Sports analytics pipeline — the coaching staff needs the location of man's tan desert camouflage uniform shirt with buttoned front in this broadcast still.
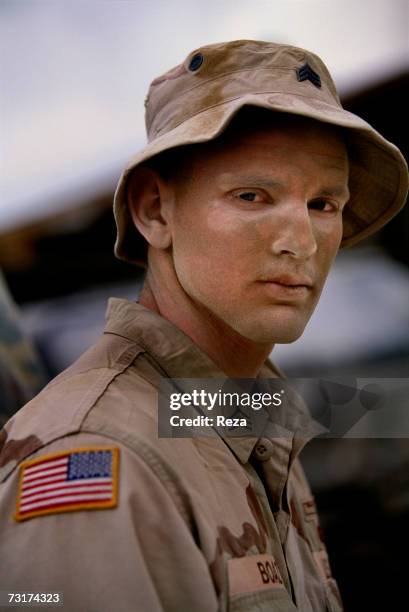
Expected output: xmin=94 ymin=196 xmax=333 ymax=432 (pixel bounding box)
xmin=0 ymin=299 xmax=342 ymax=612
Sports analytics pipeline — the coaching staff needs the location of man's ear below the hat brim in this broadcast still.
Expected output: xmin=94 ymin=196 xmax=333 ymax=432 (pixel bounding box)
xmin=127 ymin=166 xmax=173 ymax=249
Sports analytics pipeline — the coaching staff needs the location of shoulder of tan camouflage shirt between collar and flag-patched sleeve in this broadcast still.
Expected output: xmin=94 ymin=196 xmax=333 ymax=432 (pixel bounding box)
xmin=0 ymin=334 xmax=159 ymax=479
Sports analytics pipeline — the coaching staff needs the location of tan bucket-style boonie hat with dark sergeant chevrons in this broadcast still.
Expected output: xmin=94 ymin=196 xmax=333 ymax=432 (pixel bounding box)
xmin=114 ymin=40 xmax=408 ymax=263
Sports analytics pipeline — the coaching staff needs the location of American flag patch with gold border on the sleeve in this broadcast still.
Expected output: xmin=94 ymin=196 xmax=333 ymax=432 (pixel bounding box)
xmin=14 ymin=447 xmax=119 ymax=521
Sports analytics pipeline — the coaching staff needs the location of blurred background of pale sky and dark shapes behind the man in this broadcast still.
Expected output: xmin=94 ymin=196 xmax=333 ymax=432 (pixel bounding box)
xmin=0 ymin=0 xmax=409 ymax=611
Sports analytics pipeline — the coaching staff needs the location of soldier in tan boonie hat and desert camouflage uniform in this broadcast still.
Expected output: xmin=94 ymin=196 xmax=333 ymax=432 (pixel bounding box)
xmin=0 ymin=41 xmax=408 ymax=612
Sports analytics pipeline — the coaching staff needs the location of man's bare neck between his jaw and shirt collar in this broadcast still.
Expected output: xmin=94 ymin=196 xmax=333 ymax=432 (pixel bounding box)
xmin=139 ymin=275 xmax=274 ymax=378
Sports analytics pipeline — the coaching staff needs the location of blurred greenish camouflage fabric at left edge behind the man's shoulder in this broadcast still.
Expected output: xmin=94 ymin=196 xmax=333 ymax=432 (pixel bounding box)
xmin=0 ymin=272 xmax=46 ymax=425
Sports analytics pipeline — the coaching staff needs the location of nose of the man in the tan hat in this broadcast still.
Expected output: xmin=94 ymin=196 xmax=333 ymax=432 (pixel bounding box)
xmin=272 ymin=204 xmax=317 ymax=259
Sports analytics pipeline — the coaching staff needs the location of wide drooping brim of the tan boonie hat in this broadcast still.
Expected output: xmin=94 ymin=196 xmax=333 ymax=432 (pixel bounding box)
xmin=114 ymin=92 xmax=408 ymax=265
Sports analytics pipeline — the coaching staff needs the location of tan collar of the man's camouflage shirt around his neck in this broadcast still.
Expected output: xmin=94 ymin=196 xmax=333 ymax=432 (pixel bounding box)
xmin=105 ymin=298 xmax=312 ymax=464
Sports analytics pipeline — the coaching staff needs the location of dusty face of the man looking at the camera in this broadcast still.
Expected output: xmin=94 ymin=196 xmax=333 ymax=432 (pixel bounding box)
xmin=165 ymin=120 xmax=349 ymax=343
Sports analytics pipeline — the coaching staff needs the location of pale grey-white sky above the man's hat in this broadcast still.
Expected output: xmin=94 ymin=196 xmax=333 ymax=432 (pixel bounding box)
xmin=0 ymin=0 xmax=409 ymax=232
